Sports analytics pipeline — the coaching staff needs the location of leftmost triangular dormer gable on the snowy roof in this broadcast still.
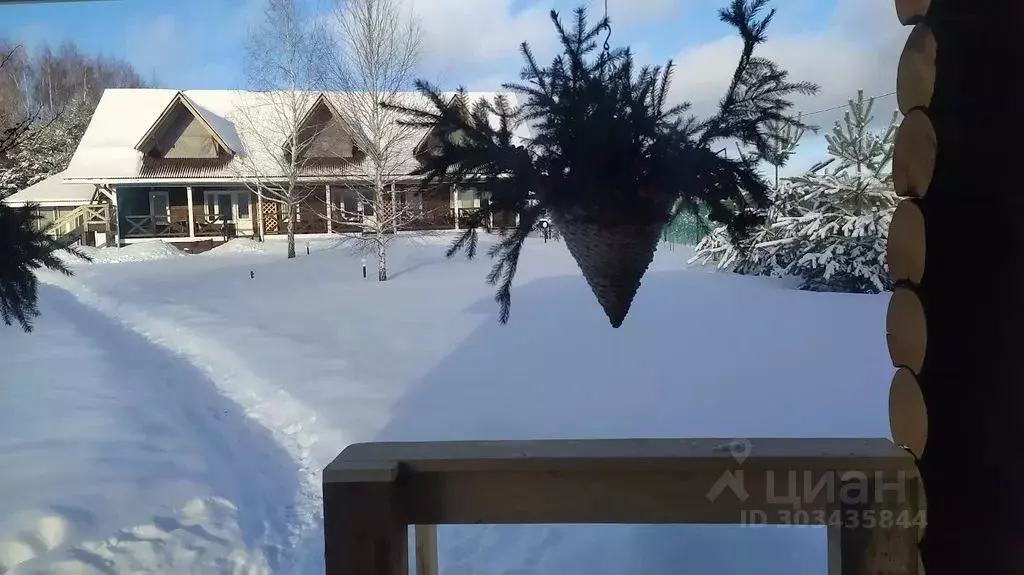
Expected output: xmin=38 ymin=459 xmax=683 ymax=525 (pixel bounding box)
xmin=135 ymin=92 xmax=234 ymax=160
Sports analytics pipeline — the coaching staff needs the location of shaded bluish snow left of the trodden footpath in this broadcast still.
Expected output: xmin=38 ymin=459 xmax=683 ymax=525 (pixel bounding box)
xmin=0 ymin=284 xmax=299 ymax=574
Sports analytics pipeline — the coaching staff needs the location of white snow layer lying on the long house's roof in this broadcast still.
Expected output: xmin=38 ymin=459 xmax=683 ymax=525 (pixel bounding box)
xmin=65 ymin=88 xmax=527 ymax=182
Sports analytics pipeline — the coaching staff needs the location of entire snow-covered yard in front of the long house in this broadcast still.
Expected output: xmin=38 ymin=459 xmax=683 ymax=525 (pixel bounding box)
xmin=0 ymin=233 xmax=892 ymax=575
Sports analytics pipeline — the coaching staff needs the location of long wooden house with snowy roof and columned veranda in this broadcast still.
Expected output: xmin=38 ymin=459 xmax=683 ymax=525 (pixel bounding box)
xmin=6 ymin=89 xmax=514 ymax=245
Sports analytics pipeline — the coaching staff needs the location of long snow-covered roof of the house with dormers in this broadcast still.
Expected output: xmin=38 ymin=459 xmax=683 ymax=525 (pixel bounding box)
xmin=65 ymin=88 xmax=528 ymax=183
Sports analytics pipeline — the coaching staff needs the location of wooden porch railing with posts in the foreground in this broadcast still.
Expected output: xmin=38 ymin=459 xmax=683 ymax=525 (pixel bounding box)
xmin=324 ymin=439 xmax=924 ymax=575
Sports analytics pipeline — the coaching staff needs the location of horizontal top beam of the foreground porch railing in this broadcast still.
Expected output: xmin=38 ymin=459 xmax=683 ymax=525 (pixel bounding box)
xmin=324 ymin=439 xmax=915 ymax=525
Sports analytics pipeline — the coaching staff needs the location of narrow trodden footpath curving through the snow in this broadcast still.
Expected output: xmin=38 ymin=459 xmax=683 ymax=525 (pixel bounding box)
xmin=39 ymin=272 xmax=323 ymax=572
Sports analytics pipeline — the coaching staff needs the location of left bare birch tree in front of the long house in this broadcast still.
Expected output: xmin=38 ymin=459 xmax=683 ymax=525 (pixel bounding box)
xmin=233 ymin=0 xmax=327 ymax=258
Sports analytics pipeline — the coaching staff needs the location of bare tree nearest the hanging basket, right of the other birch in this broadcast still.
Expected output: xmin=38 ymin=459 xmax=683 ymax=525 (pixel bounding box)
xmin=330 ymin=0 xmax=431 ymax=281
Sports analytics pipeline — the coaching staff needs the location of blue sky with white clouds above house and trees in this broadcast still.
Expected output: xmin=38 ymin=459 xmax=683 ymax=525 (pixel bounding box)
xmin=0 ymin=0 xmax=907 ymax=168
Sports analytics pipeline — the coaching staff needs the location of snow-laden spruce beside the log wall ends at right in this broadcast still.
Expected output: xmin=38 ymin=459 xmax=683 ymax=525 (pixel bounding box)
xmin=694 ymin=92 xmax=898 ymax=293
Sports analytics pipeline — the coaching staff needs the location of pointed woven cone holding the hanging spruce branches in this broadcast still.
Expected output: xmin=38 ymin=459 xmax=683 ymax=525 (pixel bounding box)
xmin=553 ymin=214 xmax=664 ymax=327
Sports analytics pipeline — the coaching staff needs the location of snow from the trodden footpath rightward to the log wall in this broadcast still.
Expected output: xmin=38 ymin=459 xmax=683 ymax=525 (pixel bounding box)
xmin=37 ymin=235 xmax=892 ymax=575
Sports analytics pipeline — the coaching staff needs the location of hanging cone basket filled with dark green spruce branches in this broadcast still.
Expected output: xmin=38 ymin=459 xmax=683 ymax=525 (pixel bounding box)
xmin=395 ymin=0 xmax=817 ymax=327
